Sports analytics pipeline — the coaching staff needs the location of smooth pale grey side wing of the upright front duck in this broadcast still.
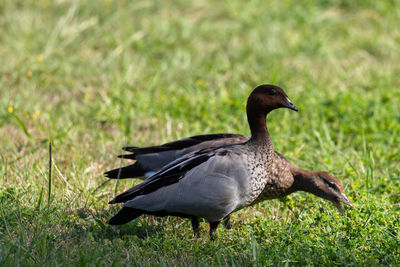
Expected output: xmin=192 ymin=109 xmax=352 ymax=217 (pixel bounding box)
xmin=125 ymin=153 xmax=249 ymax=224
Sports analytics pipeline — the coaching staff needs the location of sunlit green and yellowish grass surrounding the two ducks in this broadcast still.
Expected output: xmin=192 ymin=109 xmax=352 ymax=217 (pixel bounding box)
xmin=0 ymin=0 xmax=400 ymax=266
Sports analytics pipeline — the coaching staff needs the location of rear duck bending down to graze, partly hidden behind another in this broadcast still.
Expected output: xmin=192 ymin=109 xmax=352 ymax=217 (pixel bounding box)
xmin=105 ymin=137 xmax=353 ymax=232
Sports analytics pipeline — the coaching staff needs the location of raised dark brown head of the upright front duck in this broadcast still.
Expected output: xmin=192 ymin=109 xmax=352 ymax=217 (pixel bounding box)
xmin=247 ymin=84 xmax=298 ymax=115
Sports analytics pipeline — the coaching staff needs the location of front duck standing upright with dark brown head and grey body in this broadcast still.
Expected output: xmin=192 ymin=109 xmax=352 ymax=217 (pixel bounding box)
xmin=108 ymin=84 xmax=298 ymax=239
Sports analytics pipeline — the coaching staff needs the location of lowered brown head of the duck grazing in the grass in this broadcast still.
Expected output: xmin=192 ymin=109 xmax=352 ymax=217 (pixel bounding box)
xmin=311 ymin=172 xmax=353 ymax=214
